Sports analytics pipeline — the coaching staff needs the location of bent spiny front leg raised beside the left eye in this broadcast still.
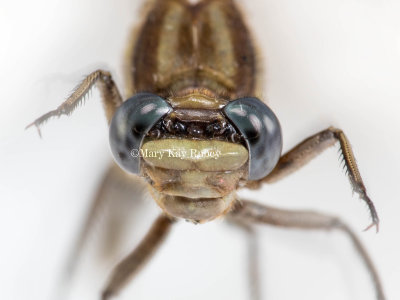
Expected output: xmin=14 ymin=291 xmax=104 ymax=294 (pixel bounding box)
xmin=26 ymin=70 xmax=122 ymax=135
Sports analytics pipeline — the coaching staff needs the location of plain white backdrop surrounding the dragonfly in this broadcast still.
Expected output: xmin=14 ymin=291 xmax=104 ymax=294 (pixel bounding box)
xmin=0 ymin=0 xmax=400 ymax=300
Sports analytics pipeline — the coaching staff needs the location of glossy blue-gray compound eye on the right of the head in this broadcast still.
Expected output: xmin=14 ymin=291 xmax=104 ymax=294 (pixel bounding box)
xmin=223 ymin=98 xmax=282 ymax=180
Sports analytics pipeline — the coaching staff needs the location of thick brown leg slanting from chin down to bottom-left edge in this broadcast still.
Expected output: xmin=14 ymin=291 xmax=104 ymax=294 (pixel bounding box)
xmin=101 ymin=215 xmax=174 ymax=300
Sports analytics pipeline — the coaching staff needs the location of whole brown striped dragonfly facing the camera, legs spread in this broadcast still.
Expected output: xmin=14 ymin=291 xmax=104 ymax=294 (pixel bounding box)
xmin=28 ymin=0 xmax=385 ymax=300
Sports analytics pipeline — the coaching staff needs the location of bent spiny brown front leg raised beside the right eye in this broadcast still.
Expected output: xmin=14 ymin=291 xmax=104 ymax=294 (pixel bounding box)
xmin=247 ymin=127 xmax=379 ymax=232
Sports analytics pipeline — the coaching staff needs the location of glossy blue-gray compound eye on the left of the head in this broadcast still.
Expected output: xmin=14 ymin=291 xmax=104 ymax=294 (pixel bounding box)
xmin=109 ymin=93 xmax=172 ymax=174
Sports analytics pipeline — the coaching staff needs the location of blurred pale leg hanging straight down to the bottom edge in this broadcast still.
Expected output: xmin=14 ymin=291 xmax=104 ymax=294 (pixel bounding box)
xmin=227 ymin=215 xmax=262 ymax=300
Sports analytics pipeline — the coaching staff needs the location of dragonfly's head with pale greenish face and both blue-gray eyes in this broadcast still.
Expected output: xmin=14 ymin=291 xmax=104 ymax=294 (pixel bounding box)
xmin=110 ymin=92 xmax=282 ymax=222
